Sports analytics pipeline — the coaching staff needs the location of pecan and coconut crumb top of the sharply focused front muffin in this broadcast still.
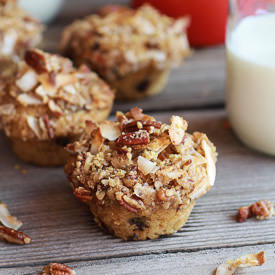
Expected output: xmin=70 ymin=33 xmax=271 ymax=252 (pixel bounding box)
xmin=65 ymin=107 xmax=216 ymax=216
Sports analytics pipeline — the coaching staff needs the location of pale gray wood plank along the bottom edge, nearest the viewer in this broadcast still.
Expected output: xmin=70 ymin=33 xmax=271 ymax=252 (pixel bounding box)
xmin=0 ymin=244 xmax=275 ymax=275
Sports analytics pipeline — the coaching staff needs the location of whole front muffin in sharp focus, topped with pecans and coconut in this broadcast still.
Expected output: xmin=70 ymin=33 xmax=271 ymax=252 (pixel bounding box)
xmin=65 ymin=107 xmax=216 ymax=240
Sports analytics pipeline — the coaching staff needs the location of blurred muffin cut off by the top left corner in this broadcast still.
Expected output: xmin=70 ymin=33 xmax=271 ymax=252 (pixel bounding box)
xmin=0 ymin=0 xmax=43 ymax=77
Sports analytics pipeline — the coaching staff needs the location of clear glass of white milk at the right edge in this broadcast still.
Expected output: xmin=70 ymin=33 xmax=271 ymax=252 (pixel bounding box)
xmin=226 ymin=0 xmax=275 ymax=156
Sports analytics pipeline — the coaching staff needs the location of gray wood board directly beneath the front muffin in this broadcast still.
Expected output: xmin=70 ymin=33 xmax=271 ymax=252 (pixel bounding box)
xmin=0 ymin=110 xmax=275 ymax=268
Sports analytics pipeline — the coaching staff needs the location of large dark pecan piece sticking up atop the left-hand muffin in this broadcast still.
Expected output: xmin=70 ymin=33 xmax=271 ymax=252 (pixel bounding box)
xmin=25 ymin=50 xmax=47 ymax=74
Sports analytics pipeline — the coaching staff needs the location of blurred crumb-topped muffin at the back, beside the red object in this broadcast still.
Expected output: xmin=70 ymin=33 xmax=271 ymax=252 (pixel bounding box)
xmin=61 ymin=5 xmax=190 ymax=100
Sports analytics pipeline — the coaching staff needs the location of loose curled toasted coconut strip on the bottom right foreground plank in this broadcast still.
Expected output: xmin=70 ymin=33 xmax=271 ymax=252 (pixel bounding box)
xmin=215 ymin=251 xmax=265 ymax=275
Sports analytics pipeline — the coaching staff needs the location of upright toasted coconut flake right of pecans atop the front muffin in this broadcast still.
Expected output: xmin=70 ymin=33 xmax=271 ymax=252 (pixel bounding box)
xmin=169 ymin=116 xmax=188 ymax=145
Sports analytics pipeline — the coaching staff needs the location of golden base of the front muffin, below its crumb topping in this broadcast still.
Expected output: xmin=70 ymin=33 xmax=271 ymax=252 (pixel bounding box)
xmin=89 ymin=199 xmax=195 ymax=240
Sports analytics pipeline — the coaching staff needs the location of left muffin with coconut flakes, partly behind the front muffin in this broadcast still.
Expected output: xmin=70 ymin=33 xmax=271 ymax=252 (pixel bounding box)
xmin=0 ymin=50 xmax=114 ymax=166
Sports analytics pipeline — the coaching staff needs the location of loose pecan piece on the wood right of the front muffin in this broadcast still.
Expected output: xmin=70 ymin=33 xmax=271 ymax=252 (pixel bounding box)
xmin=237 ymin=200 xmax=274 ymax=222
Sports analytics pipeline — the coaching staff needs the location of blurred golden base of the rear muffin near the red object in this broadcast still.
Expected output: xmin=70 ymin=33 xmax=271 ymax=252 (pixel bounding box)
xmin=109 ymin=66 xmax=170 ymax=100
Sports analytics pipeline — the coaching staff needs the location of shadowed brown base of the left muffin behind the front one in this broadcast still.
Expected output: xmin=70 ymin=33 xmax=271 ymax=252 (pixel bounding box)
xmin=10 ymin=138 xmax=72 ymax=166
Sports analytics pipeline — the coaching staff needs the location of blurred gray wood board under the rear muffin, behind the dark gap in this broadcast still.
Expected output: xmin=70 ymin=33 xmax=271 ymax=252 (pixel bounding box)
xmin=44 ymin=0 xmax=225 ymax=111
